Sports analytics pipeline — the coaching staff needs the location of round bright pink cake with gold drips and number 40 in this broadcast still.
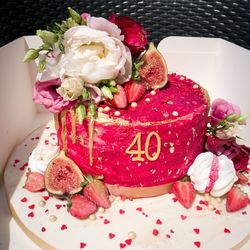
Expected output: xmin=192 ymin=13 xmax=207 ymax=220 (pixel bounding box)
xmin=56 ymin=74 xmax=209 ymax=197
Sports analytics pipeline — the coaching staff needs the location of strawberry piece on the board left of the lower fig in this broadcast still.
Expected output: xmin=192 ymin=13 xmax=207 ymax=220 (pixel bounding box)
xmin=24 ymin=172 xmax=45 ymax=192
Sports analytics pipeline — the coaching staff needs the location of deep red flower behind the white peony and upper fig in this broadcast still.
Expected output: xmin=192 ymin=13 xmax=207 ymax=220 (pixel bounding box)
xmin=109 ymin=13 xmax=148 ymax=55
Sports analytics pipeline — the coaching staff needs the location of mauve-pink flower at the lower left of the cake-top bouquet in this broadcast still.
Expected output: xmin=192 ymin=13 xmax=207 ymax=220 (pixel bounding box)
xmin=33 ymin=78 xmax=76 ymax=113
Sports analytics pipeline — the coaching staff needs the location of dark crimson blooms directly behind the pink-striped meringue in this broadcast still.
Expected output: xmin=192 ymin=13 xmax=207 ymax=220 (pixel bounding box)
xmin=206 ymin=135 xmax=250 ymax=171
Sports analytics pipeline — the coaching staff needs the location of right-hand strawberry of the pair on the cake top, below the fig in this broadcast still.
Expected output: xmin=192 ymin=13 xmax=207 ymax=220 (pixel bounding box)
xmin=124 ymin=80 xmax=146 ymax=103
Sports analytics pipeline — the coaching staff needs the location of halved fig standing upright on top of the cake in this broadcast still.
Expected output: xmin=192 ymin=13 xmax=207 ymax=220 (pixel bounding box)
xmin=139 ymin=43 xmax=168 ymax=89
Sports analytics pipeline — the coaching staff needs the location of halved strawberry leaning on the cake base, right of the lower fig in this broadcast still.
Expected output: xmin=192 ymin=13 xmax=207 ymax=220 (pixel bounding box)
xmin=83 ymin=176 xmax=110 ymax=208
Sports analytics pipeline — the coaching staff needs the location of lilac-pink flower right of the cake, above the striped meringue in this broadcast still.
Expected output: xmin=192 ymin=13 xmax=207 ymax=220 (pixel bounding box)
xmin=211 ymin=99 xmax=241 ymax=126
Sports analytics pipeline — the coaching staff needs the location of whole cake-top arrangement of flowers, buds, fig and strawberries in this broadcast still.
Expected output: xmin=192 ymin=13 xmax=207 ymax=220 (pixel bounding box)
xmin=23 ymin=8 xmax=167 ymax=118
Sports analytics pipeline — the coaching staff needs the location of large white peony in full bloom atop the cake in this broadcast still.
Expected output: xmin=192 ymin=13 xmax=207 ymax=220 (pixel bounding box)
xmin=53 ymin=26 xmax=132 ymax=84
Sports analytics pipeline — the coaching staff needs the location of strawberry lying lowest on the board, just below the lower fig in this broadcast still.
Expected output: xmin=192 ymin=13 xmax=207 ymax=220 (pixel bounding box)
xmin=68 ymin=194 xmax=97 ymax=219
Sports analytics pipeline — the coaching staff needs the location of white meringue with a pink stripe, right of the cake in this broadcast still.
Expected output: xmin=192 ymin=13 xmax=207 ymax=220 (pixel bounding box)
xmin=187 ymin=152 xmax=238 ymax=197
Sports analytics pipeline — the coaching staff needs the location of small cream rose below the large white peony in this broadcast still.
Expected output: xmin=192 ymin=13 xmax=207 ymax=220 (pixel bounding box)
xmin=56 ymin=77 xmax=83 ymax=101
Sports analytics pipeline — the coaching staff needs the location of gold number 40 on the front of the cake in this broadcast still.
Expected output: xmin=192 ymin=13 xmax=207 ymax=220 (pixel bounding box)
xmin=126 ymin=132 xmax=161 ymax=161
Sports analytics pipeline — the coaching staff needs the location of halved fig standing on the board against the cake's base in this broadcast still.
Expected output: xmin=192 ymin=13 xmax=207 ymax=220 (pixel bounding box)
xmin=45 ymin=151 xmax=84 ymax=196
